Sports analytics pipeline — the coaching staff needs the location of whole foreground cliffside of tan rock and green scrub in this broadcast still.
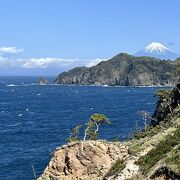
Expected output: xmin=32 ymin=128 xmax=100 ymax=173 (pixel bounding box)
xmin=38 ymin=83 xmax=180 ymax=180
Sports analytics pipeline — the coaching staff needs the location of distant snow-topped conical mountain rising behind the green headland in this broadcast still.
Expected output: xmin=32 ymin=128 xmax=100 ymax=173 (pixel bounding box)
xmin=135 ymin=42 xmax=180 ymax=60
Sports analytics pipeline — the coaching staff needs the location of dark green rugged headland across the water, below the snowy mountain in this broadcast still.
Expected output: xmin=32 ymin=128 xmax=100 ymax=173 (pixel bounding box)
xmin=54 ymin=53 xmax=180 ymax=86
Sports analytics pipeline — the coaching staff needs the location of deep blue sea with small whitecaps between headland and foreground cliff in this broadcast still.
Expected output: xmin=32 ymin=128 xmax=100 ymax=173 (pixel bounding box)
xmin=0 ymin=77 xmax=167 ymax=180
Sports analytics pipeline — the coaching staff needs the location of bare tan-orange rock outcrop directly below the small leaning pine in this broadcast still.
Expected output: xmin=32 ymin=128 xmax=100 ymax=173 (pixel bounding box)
xmin=38 ymin=141 xmax=128 ymax=180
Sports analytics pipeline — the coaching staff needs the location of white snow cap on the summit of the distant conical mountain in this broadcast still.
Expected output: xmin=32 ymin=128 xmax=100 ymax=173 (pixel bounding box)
xmin=145 ymin=42 xmax=170 ymax=53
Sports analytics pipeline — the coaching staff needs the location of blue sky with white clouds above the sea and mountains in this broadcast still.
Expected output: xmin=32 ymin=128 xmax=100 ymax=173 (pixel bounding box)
xmin=0 ymin=0 xmax=180 ymax=75
